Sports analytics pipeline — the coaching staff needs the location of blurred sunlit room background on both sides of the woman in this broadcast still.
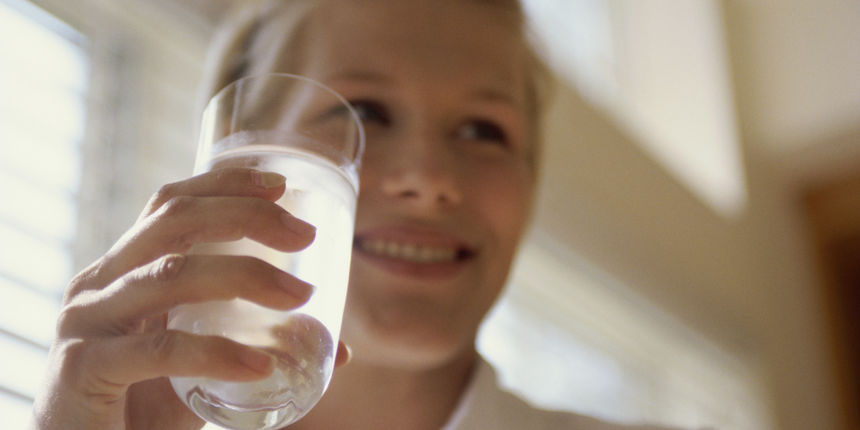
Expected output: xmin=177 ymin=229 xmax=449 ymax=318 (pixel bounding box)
xmin=0 ymin=0 xmax=860 ymax=430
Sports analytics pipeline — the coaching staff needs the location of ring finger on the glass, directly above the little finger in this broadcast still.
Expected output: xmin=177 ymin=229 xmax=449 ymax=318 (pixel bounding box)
xmin=58 ymin=254 xmax=313 ymax=337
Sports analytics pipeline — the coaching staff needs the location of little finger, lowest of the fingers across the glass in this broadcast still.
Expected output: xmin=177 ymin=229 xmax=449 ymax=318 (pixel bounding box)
xmin=57 ymin=330 xmax=275 ymax=393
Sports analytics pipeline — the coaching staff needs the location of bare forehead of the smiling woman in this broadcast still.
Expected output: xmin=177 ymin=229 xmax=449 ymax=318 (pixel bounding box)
xmin=298 ymin=0 xmax=524 ymax=95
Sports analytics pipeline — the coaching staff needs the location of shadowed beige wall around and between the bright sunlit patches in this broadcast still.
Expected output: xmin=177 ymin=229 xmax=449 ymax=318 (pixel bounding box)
xmin=520 ymin=1 xmax=860 ymax=429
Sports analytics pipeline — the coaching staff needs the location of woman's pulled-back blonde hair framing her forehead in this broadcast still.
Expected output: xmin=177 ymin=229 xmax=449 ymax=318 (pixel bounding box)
xmin=201 ymin=0 xmax=552 ymax=172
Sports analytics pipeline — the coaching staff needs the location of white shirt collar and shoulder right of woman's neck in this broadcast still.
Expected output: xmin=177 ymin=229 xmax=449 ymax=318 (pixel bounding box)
xmin=442 ymin=360 xmax=684 ymax=430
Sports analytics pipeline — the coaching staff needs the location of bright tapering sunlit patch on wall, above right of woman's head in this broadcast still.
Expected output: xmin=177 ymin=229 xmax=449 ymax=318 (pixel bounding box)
xmin=525 ymin=0 xmax=747 ymax=218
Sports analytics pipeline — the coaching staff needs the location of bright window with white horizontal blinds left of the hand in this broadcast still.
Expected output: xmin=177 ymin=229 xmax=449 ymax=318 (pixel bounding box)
xmin=0 ymin=2 xmax=87 ymax=428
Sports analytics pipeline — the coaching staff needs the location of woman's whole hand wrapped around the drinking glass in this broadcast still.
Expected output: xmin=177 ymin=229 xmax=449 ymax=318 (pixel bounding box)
xmin=42 ymin=168 xmax=326 ymax=428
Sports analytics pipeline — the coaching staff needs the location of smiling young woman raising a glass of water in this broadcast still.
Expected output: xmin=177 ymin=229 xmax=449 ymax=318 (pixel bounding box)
xmin=35 ymin=0 xmax=676 ymax=430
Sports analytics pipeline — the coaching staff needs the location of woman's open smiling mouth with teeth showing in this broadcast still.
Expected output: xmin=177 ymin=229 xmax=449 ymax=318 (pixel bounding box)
xmin=355 ymin=238 xmax=474 ymax=264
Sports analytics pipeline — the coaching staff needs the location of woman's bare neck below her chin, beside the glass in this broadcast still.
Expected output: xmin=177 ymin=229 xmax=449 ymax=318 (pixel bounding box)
xmin=290 ymin=351 xmax=477 ymax=430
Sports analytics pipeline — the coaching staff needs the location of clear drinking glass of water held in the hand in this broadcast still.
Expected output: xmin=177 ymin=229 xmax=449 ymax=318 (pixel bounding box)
xmin=168 ymin=74 xmax=364 ymax=430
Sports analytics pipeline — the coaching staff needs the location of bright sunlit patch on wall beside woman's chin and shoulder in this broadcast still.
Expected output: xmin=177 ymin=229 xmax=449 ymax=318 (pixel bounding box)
xmin=478 ymin=234 xmax=774 ymax=430
